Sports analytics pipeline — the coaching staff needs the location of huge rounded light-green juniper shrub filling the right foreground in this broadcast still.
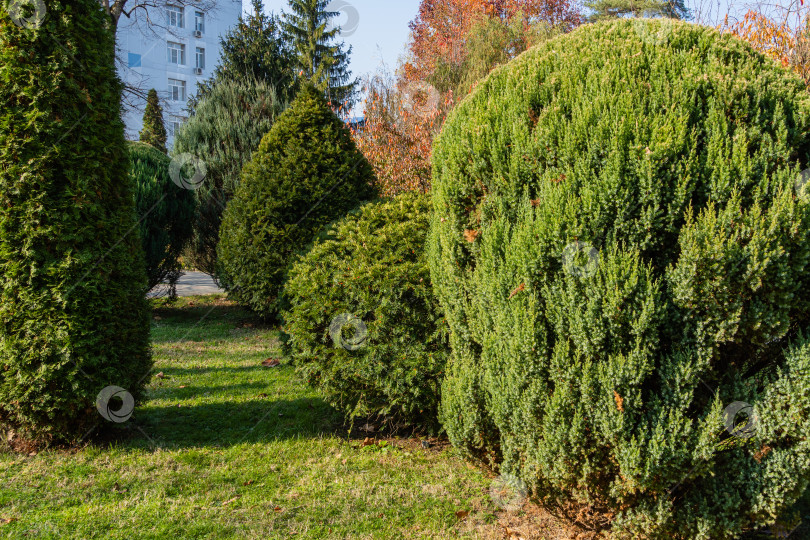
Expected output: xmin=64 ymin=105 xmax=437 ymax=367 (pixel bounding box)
xmin=429 ymin=20 xmax=810 ymax=539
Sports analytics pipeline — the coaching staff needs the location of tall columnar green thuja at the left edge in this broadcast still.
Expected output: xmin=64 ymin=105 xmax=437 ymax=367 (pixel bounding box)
xmin=0 ymin=0 xmax=151 ymax=443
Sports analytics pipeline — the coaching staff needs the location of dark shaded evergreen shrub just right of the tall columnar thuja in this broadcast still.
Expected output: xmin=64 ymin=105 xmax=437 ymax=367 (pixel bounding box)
xmin=129 ymin=142 xmax=196 ymax=296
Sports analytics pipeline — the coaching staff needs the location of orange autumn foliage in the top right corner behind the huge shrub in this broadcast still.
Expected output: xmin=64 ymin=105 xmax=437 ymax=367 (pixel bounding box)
xmin=721 ymin=0 xmax=810 ymax=85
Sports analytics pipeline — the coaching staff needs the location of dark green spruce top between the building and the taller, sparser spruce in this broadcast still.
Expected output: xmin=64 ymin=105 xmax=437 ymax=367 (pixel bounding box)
xmin=189 ymin=0 xmax=298 ymax=109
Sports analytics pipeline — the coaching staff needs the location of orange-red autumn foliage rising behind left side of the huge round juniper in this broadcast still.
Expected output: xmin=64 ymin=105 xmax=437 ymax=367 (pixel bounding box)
xmin=355 ymin=0 xmax=582 ymax=195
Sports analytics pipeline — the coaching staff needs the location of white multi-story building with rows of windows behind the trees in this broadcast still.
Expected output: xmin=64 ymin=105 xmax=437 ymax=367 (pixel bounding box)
xmin=117 ymin=0 xmax=242 ymax=146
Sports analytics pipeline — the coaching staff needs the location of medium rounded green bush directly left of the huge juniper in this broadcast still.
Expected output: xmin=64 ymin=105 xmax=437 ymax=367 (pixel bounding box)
xmin=284 ymin=193 xmax=448 ymax=428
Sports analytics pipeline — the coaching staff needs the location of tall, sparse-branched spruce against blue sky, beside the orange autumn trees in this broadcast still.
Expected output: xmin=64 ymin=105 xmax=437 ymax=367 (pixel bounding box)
xmin=283 ymin=0 xmax=358 ymax=110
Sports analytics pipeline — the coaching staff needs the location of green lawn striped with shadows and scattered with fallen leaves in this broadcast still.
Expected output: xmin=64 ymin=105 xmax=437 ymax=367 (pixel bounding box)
xmin=0 ymin=297 xmax=505 ymax=539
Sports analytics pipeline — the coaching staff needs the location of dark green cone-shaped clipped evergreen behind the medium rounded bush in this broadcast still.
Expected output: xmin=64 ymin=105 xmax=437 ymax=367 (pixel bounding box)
xmin=217 ymin=85 xmax=374 ymax=318
